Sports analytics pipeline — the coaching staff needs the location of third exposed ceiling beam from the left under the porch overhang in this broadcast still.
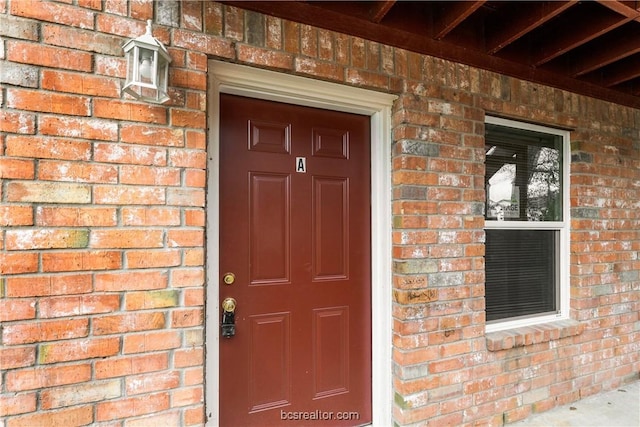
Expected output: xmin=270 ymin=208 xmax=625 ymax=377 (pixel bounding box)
xmin=487 ymin=0 xmax=578 ymax=55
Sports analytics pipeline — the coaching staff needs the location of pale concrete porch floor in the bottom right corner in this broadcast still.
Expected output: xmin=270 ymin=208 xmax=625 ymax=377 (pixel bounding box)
xmin=508 ymin=381 xmax=640 ymax=427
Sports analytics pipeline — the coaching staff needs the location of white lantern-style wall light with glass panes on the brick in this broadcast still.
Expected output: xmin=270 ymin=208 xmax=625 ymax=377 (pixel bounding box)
xmin=122 ymin=20 xmax=171 ymax=104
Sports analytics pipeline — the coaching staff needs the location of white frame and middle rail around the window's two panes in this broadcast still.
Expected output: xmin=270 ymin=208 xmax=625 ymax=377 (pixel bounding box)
xmin=485 ymin=116 xmax=571 ymax=333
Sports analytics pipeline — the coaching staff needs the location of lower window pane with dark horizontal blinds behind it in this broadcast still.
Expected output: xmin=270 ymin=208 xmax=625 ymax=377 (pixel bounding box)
xmin=485 ymin=229 xmax=559 ymax=321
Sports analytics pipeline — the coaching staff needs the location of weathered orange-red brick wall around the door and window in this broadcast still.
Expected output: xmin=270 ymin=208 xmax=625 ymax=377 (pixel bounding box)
xmin=0 ymin=0 xmax=640 ymax=427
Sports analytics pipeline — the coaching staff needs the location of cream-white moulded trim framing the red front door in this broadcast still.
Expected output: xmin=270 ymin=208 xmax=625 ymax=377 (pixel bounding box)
xmin=205 ymin=60 xmax=396 ymax=426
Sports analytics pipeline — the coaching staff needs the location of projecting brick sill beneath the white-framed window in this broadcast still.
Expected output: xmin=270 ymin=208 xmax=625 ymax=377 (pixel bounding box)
xmin=485 ymin=319 xmax=584 ymax=351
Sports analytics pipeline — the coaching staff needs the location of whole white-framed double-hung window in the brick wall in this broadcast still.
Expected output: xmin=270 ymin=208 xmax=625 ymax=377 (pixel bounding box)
xmin=485 ymin=117 xmax=569 ymax=331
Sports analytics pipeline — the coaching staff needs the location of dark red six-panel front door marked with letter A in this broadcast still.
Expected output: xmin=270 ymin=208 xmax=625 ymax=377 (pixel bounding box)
xmin=220 ymin=95 xmax=371 ymax=426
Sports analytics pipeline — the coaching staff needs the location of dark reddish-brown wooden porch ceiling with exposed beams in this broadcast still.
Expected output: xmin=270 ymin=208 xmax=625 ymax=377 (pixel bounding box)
xmin=224 ymin=0 xmax=640 ymax=108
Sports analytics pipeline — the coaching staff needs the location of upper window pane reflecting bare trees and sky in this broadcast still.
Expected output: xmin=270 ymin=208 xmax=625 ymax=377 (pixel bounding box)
xmin=485 ymin=124 xmax=562 ymax=221
